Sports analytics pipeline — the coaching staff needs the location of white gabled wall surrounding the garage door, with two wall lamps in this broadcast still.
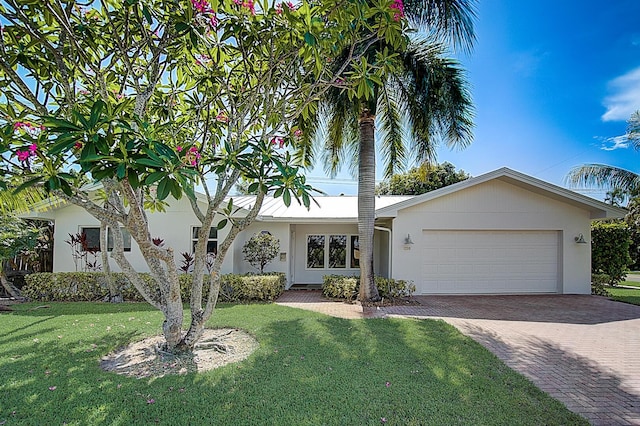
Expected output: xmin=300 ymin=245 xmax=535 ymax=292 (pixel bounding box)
xmin=392 ymin=180 xmax=591 ymax=294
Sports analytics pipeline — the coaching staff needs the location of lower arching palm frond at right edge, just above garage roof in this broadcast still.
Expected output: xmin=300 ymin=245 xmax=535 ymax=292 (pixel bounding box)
xmin=566 ymin=164 xmax=640 ymax=193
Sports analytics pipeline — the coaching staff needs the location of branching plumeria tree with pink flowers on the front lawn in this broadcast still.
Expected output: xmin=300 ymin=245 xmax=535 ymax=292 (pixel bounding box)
xmin=0 ymin=0 xmax=406 ymax=352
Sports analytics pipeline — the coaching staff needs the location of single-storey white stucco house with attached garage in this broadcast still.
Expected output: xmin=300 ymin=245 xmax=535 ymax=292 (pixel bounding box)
xmin=26 ymin=168 xmax=625 ymax=294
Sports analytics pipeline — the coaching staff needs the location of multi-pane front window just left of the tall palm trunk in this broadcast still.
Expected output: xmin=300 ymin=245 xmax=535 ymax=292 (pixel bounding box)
xmin=307 ymin=235 xmax=360 ymax=269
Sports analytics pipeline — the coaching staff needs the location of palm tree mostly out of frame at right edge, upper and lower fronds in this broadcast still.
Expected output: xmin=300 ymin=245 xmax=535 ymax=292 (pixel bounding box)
xmin=567 ymin=111 xmax=640 ymax=194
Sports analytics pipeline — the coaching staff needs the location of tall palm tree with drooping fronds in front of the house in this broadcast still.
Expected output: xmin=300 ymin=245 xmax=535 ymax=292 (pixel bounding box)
xmin=303 ymin=0 xmax=475 ymax=301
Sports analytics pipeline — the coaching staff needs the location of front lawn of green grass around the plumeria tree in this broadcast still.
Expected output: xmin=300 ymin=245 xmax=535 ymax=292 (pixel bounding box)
xmin=0 ymin=303 xmax=587 ymax=426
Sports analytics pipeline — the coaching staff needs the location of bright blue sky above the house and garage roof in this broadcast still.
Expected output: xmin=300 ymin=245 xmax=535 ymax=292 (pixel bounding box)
xmin=309 ymin=0 xmax=640 ymax=198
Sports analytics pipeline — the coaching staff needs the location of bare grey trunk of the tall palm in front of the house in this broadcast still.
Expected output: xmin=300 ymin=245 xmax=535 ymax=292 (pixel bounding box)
xmin=358 ymin=109 xmax=380 ymax=301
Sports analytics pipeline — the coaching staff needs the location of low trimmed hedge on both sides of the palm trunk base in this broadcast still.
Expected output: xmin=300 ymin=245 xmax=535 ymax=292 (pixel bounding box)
xmin=322 ymin=275 xmax=416 ymax=300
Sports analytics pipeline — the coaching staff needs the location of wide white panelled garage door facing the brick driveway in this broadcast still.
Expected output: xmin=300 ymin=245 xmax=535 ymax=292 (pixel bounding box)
xmin=416 ymin=231 xmax=558 ymax=294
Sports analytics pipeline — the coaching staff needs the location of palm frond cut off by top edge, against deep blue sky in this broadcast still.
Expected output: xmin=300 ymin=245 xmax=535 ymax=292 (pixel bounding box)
xmin=404 ymin=0 xmax=477 ymax=52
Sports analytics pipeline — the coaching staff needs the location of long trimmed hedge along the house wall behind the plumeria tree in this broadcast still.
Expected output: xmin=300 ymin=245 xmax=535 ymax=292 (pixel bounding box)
xmin=22 ymin=272 xmax=286 ymax=302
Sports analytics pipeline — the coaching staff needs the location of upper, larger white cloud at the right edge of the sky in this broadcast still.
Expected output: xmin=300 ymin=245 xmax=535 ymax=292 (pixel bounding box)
xmin=602 ymin=67 xmax=640 ymax=121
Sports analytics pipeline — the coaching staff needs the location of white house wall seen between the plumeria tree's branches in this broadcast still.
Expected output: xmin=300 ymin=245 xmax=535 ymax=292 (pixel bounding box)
xmin=53 ymin=198 xmax=234 ymax=273
